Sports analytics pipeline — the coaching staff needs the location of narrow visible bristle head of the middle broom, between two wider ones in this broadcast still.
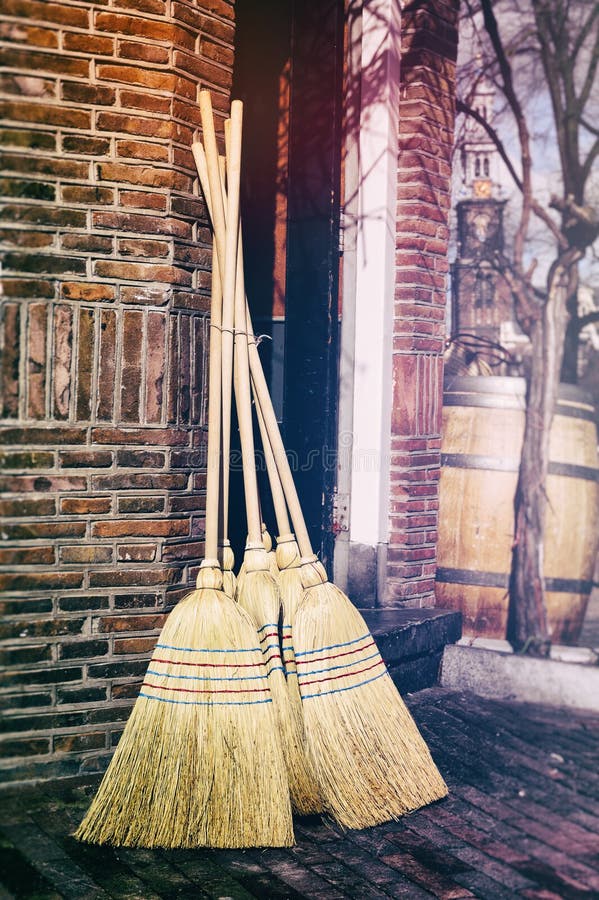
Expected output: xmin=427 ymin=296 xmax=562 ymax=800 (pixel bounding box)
xmin=237 ymin=548 xmax=322 ymax=814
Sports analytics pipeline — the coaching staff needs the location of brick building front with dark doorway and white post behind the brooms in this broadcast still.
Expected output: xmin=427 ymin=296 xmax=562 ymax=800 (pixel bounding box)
xmin=0 ymin=0 xmax=457 ymax=781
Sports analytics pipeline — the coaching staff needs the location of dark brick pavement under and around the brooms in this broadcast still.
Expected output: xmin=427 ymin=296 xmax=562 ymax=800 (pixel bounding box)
xmin=0 ymin=688 xmax=599 ymax=900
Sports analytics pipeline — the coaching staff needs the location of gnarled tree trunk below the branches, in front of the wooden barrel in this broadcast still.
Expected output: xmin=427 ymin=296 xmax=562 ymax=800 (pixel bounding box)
xmin=508 ymin=263 xmax=570 ymax=656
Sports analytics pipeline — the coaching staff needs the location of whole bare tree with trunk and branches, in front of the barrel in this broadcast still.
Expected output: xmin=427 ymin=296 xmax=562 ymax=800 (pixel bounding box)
xmin=458 ymin=0 xmax=599 ymax=655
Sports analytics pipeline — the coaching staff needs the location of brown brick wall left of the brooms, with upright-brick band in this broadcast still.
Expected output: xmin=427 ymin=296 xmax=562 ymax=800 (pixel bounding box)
xmin=0 ymin=0 xmax=234 ymax=779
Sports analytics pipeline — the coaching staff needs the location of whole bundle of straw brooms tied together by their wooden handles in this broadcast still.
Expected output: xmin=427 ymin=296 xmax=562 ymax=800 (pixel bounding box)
xmin=75 ymin=91 xmax=447 ymax=848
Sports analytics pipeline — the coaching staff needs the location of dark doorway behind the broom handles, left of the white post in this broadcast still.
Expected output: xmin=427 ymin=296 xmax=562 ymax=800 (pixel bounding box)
xmin=231 ymin=0 xmax=344 ymax=567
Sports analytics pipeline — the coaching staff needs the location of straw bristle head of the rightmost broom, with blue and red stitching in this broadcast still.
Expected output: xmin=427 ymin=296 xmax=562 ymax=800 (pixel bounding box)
xmin=292 ymin=561 xmax=447 ymax=828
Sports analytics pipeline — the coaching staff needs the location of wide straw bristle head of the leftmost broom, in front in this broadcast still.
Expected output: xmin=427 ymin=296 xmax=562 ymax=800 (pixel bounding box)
xmin=75 ymin=573 xmax=293 ymax=848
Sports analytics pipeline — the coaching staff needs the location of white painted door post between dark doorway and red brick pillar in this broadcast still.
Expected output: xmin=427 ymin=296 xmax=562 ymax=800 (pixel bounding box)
xmin=335 ymin=0 xmax=400 ymax=596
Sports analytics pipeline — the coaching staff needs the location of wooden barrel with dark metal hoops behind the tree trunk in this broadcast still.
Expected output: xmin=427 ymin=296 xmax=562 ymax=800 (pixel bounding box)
xmin=436 ymin=376 xmax=599 ymax=643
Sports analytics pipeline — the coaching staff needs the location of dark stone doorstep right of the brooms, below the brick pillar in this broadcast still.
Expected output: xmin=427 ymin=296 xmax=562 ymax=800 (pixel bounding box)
xmin=360 ymin=609 xmax=462 ymax=694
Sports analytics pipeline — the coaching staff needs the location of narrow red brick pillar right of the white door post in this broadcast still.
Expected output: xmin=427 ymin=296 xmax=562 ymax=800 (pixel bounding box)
xmin=383 ymin=0 xmax=459 ymax=606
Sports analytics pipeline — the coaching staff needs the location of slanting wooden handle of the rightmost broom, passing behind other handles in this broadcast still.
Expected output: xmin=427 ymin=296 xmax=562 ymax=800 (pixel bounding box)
xmin=192 ymin=121 xmax=313 ymax=556
